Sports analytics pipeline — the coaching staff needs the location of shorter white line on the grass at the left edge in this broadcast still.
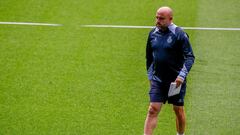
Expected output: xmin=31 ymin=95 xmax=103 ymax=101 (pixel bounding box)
xmin=0 ymin=22 xmax=62 ymax=26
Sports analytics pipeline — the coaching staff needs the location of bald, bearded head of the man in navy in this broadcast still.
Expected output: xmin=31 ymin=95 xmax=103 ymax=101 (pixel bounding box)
xmin=156 ymin=7 xmax=173 ymax=30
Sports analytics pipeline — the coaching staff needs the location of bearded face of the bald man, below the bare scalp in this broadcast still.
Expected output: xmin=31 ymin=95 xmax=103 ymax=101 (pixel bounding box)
xmin=156 ymin=12 xmax=172 ymax=29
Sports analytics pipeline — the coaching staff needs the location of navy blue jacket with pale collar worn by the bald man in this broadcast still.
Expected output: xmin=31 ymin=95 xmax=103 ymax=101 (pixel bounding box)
xmin=146 ymin=23 xmax=195 ymax=83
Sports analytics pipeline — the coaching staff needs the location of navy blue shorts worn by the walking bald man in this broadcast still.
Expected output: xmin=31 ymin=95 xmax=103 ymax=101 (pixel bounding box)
xmin=149 ymin=80 xmax=186 ymax=106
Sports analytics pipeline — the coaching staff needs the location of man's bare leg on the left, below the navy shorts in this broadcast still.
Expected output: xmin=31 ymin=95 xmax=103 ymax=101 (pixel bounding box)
xmin=144 ymin=102 xmax=162 ymax=135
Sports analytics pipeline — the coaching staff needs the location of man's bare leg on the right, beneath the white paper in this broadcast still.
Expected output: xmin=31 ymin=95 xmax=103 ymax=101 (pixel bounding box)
xmin=173 ymin=105 xmax=186 ymax=134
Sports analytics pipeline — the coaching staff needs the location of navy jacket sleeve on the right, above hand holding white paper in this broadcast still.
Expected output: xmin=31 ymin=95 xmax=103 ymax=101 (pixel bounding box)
xmin=178 ymin=31 xmax=195 ymax=80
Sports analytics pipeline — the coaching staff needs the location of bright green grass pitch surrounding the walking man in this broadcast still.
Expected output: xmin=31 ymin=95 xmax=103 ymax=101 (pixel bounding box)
xmin=0 ymin=0 xmax=240 ymax=135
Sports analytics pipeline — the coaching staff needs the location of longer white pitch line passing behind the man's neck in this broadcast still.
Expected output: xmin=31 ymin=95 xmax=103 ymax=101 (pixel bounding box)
xmin=81 ymin=25 xmax=240 ymax=31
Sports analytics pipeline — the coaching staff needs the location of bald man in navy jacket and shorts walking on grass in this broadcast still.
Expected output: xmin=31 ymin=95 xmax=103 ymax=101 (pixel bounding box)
xmin=144 ymin=7 xmax=195 ymax=135
